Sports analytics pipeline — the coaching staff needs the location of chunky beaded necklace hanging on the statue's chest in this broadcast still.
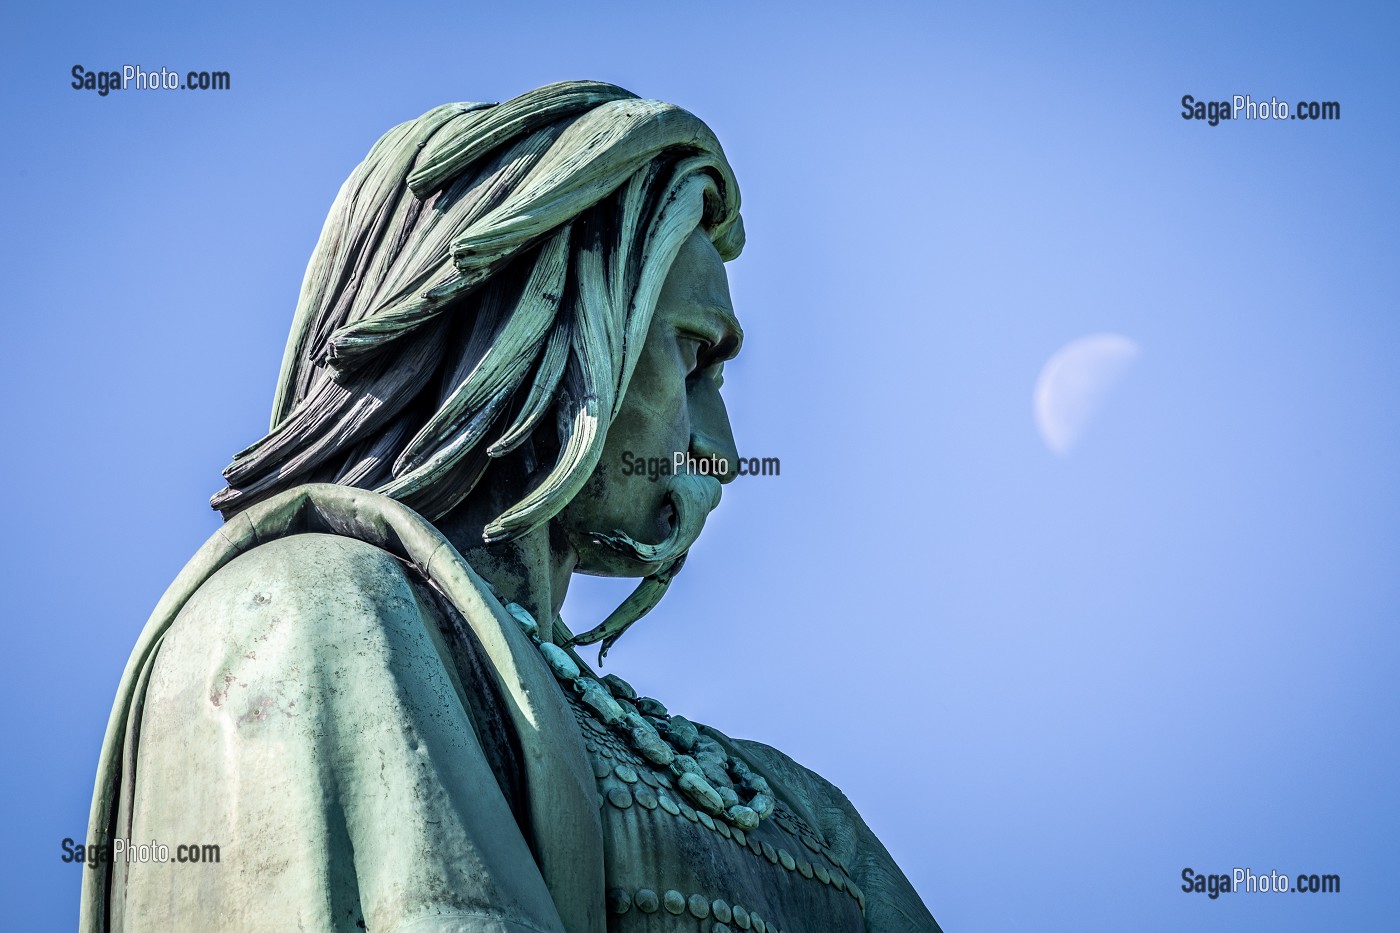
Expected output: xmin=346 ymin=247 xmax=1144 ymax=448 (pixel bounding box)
xmin=505 ymin=602 xmax=774 ymax=832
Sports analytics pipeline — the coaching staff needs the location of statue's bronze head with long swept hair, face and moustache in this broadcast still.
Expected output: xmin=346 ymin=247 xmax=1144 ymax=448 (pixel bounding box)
xmin=211 ymin=81 xmax=743 ymax=647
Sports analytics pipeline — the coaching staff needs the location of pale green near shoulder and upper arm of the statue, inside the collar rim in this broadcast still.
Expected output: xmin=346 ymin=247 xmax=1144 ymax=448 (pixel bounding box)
xmin=112 ymin=534 xmax=579 ymax=933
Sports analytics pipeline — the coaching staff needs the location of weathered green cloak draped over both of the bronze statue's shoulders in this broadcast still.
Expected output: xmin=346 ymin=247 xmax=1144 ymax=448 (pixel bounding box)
xmin=80 ymin=485 xmax=938 ymax=933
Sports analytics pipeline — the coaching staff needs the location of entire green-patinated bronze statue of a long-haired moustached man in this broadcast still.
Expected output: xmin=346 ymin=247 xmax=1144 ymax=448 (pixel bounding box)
xmin=83 ymin=83 xmax=938 ymax=933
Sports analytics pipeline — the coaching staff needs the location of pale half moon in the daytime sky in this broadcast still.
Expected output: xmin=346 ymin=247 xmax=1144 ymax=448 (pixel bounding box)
xmin=1035 ymin=333 xmax=1140 ymax=457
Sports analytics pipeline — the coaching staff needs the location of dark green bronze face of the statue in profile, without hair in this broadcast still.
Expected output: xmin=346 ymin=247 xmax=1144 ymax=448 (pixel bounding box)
xmin=559 ymin=231 xmax=743 ymax=576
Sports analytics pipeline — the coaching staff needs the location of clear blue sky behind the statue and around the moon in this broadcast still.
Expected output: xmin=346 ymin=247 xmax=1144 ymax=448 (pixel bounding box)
xmin=0 ymin=3 xmax=1400 ymax=933
